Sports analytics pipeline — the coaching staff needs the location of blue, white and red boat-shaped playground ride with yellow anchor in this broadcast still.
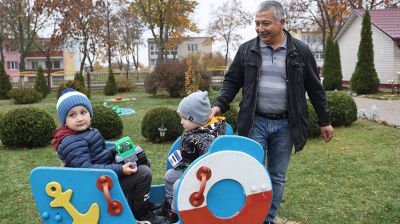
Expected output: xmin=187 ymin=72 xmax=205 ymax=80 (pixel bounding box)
xmin=30 ymin=135 xmax=272 ymax=224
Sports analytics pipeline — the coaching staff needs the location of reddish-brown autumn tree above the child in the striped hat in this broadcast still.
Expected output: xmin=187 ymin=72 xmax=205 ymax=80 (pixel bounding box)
xmin=58 ymin=0 xmax=105 ymax=74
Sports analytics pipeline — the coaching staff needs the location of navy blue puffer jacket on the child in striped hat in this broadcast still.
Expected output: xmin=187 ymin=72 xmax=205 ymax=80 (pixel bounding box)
xmin=57 ymin=128 xmax=122 ymax=176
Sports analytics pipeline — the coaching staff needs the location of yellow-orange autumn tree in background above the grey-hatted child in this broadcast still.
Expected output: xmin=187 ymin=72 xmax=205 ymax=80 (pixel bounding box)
xmin=131 ymin=0 xmax=198 ymax=63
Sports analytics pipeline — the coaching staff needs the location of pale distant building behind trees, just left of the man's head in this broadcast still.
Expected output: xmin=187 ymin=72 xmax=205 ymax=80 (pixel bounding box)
xmin=147 ymin=36 xmax=212 ymax=69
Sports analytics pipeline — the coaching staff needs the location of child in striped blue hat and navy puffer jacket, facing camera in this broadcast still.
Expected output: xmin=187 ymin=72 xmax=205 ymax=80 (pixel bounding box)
xmin=51 ymin=88 xmax=164 ymax=223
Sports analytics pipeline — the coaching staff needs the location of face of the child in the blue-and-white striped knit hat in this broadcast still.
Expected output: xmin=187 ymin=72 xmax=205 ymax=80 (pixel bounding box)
xmin=65 ymin=106 xmax=91 ymax=131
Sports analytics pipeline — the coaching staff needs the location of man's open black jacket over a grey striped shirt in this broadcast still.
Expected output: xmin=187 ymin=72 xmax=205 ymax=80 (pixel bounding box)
xmin=215 ymin=30 xmax=330 ymax=151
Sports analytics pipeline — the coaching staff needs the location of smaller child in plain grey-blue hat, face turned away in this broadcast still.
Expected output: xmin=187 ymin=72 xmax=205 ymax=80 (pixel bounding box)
xmin=155 ymin=91 xmax=226 ymax=223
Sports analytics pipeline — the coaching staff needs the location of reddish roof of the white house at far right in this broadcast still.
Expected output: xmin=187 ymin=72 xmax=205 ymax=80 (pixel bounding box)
xmin=354 ymin=8 xmax=400 ymax=40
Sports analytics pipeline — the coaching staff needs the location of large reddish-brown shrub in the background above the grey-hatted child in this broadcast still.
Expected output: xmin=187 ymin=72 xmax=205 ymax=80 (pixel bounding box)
xmin=153 ymin=60 xmax=187 ymax=97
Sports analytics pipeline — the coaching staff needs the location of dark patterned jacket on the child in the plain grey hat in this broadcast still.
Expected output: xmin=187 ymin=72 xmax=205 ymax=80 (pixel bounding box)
xmin=180 ymin=117 xmax=226 ymax=164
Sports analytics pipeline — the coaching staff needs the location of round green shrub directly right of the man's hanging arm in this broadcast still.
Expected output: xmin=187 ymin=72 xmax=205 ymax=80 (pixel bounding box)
xmin=327 ymin=91 xmax=357 ymax=126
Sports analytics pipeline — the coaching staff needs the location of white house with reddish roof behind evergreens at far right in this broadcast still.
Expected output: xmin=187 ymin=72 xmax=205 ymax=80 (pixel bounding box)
xmin=335 ymin=8 xmax=400 ymax=89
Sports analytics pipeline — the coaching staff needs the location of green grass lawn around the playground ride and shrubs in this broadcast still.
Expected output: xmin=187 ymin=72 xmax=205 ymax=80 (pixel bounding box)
xmin=0 ymin=90 xmax=400 ymax=224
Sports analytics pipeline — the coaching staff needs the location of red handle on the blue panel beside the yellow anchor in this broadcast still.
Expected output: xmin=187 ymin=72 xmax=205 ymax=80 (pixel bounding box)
xmin=96 ymin=175 xmax=123 ymax=215
